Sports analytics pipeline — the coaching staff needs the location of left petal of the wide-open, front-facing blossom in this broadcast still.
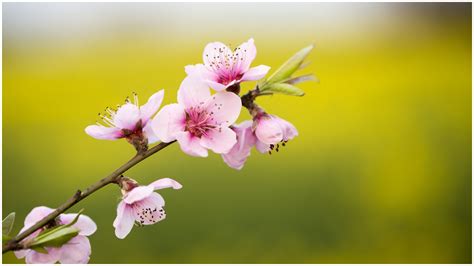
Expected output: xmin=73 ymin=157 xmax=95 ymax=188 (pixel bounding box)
xmin=151 ymin=103 xmax=186 ymax=142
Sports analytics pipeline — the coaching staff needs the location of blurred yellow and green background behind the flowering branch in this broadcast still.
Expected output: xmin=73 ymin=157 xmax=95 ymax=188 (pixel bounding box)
xmin=2 ymin=3 xmax=472 ymax=263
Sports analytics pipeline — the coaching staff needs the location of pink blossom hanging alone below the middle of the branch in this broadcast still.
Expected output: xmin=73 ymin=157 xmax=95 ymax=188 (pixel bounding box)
xmin=113 ymin=178 xmax=182 ymax=239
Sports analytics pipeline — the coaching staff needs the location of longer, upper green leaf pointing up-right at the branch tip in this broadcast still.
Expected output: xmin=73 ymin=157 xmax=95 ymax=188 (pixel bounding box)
xmin=259 ymin=45 xmax=314 ymax=91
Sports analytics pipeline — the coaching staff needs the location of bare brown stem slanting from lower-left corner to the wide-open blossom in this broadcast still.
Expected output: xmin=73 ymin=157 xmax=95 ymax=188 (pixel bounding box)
xmin=2 ymin=141 xmax=175 ymax=253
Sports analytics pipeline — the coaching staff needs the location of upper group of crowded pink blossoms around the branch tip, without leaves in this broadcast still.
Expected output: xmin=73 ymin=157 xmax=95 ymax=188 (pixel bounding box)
xmin=86 ymin=39 xmax=298 ymax=169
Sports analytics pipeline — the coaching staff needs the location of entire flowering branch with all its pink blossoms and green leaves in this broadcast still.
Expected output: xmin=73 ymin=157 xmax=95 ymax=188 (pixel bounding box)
xmin=2 ymin=39 xmax=314 ymax=263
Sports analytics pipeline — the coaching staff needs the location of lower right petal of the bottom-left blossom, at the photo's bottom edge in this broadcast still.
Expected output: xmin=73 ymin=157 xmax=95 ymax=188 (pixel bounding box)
xmin=59 ymin=235 xmax=91 ymax=264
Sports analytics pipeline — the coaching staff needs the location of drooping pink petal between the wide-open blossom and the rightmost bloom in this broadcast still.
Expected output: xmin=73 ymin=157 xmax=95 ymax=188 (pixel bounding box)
xmin=222 ymin=120 xmax=257 ymax=170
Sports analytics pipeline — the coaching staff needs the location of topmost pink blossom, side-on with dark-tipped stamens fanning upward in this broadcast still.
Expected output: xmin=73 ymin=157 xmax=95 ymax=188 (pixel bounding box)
xmin=185 ymin=39 xmax=270 ymax=91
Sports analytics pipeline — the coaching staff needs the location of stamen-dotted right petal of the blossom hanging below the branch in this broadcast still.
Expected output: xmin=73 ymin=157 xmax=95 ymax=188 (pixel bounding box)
xmin=133 ymin=192 xmax=166 ymax=225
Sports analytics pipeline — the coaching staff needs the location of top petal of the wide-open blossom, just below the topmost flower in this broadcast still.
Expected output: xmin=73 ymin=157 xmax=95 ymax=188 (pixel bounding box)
xmin=178 ymin=76 xmax=211 ymax=108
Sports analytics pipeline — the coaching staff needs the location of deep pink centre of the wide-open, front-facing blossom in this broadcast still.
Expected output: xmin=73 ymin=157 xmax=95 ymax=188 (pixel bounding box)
xmin=185 ymin=107 xmax=216 ymax=138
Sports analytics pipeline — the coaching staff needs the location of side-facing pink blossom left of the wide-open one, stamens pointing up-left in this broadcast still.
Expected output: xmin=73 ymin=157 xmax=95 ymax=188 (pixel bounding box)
xmin=86 ymin=90 xmax=164 ymax=143
